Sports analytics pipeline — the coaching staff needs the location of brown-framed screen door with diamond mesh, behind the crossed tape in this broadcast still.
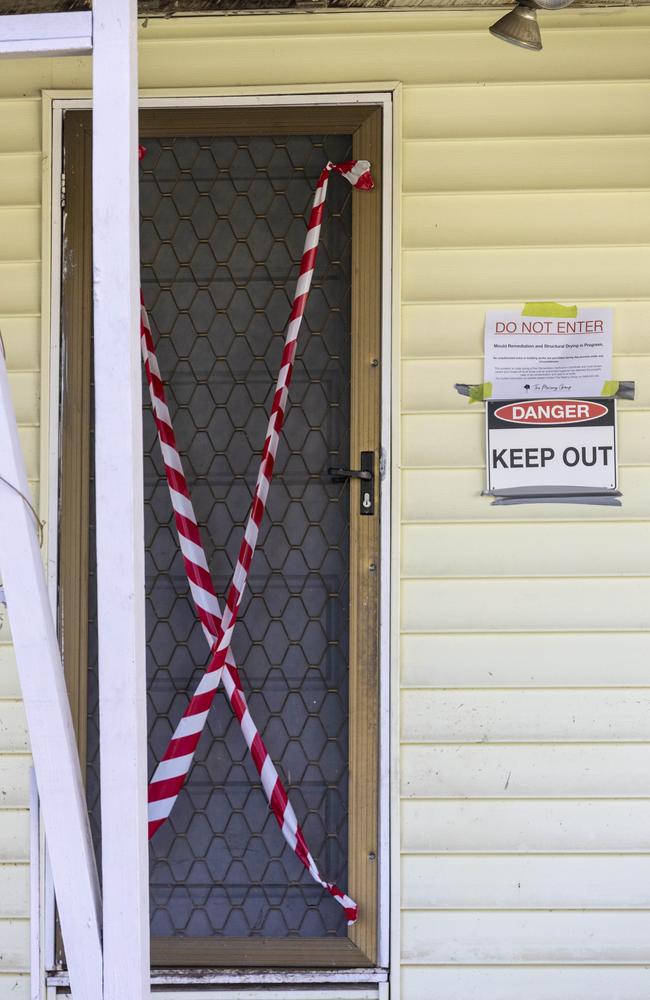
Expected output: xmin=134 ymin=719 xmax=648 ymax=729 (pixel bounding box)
xmin=62 ymin=103 xmax=381 ymax=966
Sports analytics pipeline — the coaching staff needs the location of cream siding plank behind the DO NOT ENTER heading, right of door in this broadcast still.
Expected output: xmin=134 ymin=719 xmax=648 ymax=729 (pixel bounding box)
xmin=402 ymin=298 xmax=650 ymax=358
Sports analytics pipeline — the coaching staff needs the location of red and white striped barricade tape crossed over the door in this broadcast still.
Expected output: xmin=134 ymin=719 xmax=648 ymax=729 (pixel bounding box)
xmin=141 ymin=160 xmax=373 ymax=923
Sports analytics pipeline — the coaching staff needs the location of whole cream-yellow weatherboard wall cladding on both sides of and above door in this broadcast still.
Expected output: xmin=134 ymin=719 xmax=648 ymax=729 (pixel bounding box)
xmin=0 ymin=8 xmax=650 ymax=1000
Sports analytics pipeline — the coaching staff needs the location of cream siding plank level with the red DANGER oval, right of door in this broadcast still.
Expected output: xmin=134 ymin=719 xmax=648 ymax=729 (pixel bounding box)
xmin=401 ymin=401 xmax=650 ymax=468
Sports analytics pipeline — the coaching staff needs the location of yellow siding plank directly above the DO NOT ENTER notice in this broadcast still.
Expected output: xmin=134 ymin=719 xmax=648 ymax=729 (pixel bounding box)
xmin=402 ymin=246 xmax=650 ymax=304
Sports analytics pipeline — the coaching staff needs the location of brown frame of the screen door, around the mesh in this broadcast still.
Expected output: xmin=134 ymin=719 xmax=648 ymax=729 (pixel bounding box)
xmin=59 ymin=103 xmax=388 ymax=969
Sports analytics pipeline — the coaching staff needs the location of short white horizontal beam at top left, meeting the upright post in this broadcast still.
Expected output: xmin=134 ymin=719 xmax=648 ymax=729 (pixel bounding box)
xmin=0 ymin=10 xmax=93 ymax=57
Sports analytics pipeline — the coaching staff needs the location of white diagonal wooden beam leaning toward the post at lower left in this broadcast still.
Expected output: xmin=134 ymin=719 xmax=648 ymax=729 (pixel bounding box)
xmin=0 ymin=351 xmax=102 ymax=1000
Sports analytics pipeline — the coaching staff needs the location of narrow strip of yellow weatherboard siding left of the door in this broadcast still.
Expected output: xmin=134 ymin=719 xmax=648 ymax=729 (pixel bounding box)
xmin=0 ymin=86 xmax=41 ymax=1000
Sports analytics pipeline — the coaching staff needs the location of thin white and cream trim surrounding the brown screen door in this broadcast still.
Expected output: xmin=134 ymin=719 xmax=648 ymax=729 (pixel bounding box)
xmin=45 ymin=83 xmax=392 ymax=988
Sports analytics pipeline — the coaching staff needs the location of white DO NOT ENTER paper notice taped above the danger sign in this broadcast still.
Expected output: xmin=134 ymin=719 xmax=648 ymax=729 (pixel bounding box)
xmin=484 ymin=308 xmax=613 ymax=399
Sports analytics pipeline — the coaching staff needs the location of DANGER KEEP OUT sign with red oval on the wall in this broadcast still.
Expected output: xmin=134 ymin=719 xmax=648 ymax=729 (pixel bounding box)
xmin=486 ymin=398 xmax=617 ymax=492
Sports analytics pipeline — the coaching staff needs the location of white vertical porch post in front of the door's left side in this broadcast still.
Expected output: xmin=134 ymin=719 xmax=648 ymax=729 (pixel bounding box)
xmin=93 ymin=0 xmax=150 ymax=1000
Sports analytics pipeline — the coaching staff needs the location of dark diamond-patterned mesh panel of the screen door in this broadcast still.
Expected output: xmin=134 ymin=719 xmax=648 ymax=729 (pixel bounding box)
xmin=88 ymin=136 xmax=351 ymax=937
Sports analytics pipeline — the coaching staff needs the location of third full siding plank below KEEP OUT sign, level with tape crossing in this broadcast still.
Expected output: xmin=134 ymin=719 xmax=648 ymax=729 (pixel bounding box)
xmin=401 ymin=631 xmax=650 ymax=688
